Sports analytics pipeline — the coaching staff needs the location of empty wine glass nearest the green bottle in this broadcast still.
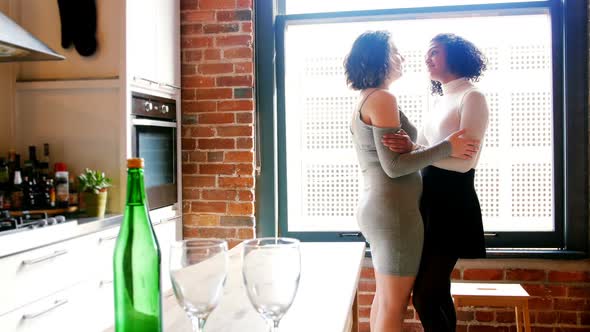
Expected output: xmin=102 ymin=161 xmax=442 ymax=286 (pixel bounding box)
xmin=170 ymin=239 xmax=228 ymax=332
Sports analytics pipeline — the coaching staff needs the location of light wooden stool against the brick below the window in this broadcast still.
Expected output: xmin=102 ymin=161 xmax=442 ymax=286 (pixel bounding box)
xmin=451 ymin=282 xmax=531 ymax=332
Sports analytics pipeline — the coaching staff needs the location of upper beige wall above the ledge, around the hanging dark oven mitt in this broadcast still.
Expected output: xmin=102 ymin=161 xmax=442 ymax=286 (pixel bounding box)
xmin=15 ymin=0 xmax=124 ymax=80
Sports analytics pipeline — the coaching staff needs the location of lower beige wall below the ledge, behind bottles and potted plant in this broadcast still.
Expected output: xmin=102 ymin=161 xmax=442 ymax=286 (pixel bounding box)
xmin=16 ymin=80 xmax=126 ymax=212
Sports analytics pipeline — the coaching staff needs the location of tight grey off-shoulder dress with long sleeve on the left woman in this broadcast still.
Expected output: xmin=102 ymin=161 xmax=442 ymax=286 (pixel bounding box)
xmin=350 ymin=97 xmax=451 ymax=276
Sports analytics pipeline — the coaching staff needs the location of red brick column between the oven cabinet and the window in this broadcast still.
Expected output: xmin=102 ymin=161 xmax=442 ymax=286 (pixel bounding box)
xmin=181 ymin=0 xmax=255 ymax=246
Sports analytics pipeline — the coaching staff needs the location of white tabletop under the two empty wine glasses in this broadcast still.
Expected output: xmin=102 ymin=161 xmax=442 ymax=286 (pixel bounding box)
xmin=107 ymin=242 xmax=365 ymax=332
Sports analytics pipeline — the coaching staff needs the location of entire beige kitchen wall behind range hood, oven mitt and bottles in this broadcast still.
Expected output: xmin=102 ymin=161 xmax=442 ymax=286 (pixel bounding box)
xmin=0 ymin=0 xmax=125 ymax=212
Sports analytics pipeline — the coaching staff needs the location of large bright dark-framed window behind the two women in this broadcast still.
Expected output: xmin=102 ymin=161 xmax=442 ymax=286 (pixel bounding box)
xmin=257 ymin=0 xmax=588 ymax=251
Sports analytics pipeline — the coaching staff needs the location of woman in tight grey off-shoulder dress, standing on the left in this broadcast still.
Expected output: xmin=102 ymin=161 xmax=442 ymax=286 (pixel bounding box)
xmin=344 ymin=31 xmax=478 ymax=332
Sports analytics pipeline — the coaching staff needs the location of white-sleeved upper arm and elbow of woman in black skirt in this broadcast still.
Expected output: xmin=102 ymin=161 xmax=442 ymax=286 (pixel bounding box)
xmin=434 ymin=90 xmax=489 ymax=173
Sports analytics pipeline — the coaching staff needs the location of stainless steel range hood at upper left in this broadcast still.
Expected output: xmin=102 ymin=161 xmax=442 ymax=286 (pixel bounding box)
xmin=0 ymin=12 xmax=65 ymax=62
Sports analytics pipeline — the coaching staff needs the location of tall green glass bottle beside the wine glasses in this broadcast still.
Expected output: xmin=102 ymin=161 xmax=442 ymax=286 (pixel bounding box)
xmin=113 ymin=158 xmax=162 ymax=332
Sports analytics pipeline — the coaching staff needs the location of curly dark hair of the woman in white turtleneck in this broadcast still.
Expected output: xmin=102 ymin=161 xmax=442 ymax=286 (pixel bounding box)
xmin=430 ymin=33 xmax=488 ymax=96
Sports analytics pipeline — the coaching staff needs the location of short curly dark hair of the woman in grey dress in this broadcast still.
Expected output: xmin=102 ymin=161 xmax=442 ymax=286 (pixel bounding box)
xmin=344 ymin=30 xmax=395 ymax=90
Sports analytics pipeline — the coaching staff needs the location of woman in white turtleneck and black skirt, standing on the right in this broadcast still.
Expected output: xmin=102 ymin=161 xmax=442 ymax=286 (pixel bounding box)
xmin=383 ymin=34 xmax=488 ymax=332
